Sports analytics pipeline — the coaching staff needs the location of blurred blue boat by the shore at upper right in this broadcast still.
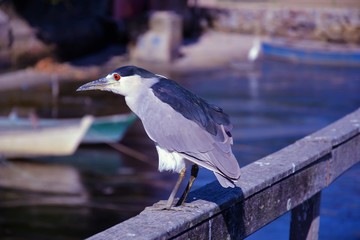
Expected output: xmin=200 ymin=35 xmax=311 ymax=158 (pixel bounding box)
xmin=261 ymin=39 xmax=360 ymax=65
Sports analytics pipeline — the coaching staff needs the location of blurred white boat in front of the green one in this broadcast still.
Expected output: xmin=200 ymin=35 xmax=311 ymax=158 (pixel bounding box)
xmin=0 ymin=116 xmax=93 ymax=157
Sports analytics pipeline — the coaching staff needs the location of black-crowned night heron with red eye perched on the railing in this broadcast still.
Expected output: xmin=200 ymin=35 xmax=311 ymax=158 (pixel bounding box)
xmin=77 ymin=66 xmax=240 ymax=208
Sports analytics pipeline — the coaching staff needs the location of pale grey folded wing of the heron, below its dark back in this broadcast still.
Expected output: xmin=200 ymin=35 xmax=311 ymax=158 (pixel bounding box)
xmin=139 ymin=86 xmax=240 ymax=182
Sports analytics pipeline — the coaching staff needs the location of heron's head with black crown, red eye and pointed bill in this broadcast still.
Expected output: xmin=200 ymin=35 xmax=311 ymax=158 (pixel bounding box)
xmin=76 ymin=66 xmax=159 ymax=96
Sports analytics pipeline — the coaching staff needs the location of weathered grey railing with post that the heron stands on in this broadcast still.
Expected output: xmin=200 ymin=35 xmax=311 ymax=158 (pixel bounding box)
xmin=89 ymin=109 xmax=360 ymax=240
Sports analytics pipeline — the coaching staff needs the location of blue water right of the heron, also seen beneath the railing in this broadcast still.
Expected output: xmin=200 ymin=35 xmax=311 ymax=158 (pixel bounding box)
xmin=186 ymin=61 xmax=360 ymax=240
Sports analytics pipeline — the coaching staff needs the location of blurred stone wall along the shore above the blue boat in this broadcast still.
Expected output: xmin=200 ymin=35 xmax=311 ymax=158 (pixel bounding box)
xmin=200 ymin=7 xmax=360 ymax=44
